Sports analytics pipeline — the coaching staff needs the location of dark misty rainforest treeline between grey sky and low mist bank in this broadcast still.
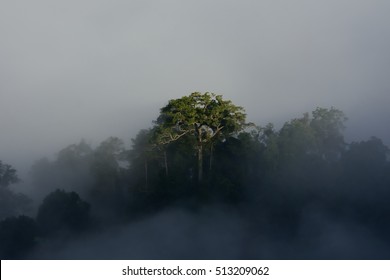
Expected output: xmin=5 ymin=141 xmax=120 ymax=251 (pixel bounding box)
xmin=0 ymin=93 xmax=390 ymax=259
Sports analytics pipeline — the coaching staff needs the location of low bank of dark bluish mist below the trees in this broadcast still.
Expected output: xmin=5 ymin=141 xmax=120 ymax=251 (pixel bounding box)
xmin=28 ymin=207 xmax=390 ymax=260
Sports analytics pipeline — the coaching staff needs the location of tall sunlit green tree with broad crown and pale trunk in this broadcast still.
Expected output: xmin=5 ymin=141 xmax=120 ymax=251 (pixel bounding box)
xmin=155 ymin=92 xmax=246 ymax=182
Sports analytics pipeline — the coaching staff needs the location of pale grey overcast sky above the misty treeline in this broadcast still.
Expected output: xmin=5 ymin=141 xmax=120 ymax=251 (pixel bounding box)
xmin=0 ymin=0 xmax=390 ymax=175
